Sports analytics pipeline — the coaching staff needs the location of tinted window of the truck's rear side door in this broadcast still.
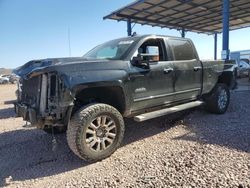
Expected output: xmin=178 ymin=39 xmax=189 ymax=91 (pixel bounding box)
xmin=168 ymin=39 xmax=196 ymax=61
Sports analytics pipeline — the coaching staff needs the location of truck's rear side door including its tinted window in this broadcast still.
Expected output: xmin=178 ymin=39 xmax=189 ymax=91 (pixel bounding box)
xmin=167 ymin=39 xmax=202 ymax=102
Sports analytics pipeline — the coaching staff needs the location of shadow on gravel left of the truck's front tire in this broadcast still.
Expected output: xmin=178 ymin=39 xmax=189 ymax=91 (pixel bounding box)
xmin=0 ymin=129 xmax=88 ymax=187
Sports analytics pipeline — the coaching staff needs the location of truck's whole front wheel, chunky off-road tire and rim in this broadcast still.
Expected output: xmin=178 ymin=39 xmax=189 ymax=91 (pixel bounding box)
xmin=67 ymin=103 xmax=125 ymax=161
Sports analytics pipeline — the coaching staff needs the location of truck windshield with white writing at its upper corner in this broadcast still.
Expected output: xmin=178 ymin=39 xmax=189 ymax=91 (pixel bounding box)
xmin=83 ymin=38 xmax=134 ymax=60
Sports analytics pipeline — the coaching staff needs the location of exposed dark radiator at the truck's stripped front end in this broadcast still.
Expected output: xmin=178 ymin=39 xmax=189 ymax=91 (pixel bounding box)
xmin=19 ymin=76 xmax=41 ymax=108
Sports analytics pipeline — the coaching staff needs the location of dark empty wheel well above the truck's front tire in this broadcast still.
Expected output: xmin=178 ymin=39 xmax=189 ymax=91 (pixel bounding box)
xmin=73 ymin=87 xmax=125 ymax=114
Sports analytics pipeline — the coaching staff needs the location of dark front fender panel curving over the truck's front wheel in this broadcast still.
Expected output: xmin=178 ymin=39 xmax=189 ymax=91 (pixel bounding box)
xmin=57 ymin=70 xmax=131 ymax=114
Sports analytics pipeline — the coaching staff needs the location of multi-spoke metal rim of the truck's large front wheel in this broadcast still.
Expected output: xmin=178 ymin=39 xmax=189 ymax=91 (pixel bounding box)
xmin=85 ymin=115 xmax=117 ymax=152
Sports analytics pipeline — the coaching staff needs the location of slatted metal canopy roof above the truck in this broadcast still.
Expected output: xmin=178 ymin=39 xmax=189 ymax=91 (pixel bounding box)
xmin=104 ymin=0 xmax=250 ymax=34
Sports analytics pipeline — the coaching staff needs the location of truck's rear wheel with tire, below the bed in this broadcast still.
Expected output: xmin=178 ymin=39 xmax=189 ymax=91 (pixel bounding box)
xmin=205 ymin=84 xmax=230 ymax=114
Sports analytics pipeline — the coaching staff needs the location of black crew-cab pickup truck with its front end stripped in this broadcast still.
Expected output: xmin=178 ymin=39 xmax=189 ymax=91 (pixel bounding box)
xmin=15 ymin=35 xmax=234 ymax=161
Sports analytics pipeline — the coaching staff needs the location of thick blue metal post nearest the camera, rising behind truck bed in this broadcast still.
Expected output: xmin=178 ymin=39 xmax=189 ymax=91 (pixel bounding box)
xmin=222 ymin=0 xmax=230 ymax=60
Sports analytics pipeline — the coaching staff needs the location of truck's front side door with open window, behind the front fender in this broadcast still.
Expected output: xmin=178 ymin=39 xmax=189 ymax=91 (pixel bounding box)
xmin=130 ymin=39 xmax=174 ymax=111
